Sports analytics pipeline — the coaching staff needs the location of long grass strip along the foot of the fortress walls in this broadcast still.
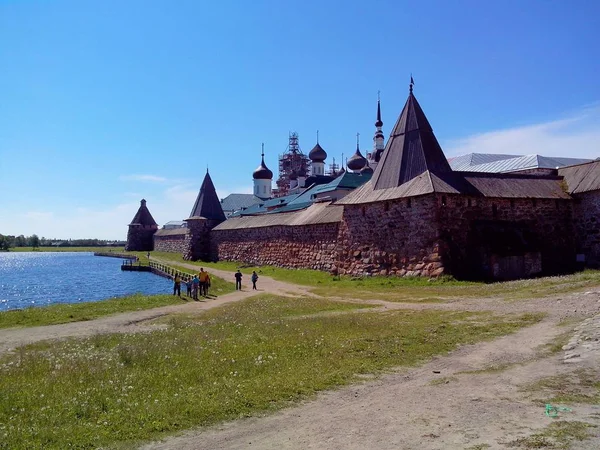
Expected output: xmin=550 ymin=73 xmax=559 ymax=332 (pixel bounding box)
xmin=136 ymin=252 xmax=600 ymax=303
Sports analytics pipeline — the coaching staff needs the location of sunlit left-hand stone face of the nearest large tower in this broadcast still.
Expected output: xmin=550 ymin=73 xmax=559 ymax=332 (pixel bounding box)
xmin=336 ymin=195 xmax=445 ymax=277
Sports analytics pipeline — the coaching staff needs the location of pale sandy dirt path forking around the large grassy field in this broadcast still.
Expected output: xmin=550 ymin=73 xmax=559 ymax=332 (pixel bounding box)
xmin=0 ymin=264 xmax=600 ymax=450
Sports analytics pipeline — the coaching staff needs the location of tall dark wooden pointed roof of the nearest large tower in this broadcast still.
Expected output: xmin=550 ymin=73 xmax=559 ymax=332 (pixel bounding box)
xmin=372 ymin=81 xmax=452 ymax=189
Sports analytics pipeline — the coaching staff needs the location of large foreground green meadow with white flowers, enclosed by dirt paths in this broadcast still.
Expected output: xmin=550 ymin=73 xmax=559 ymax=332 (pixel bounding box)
xmin=0 ymin=295 xmax=537 ymax=449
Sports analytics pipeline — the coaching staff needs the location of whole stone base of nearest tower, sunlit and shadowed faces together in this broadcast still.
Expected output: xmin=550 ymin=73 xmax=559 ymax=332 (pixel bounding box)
xmin=336 ymin=194 xmax=575 ymax=279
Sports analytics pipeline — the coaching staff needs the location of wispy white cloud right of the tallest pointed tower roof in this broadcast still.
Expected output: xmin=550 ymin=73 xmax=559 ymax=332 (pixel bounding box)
xmin=443 ymin=105 xmax=600 ymax=159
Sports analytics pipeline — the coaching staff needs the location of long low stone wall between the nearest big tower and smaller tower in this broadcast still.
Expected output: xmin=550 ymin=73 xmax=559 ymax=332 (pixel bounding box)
xmin=211 ymin=223 xmax=339 ymax=271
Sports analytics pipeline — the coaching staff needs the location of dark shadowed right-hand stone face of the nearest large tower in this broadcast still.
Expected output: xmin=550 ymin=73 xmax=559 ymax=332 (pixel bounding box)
xmin=437 ymin=194 xmax=575 ymax=279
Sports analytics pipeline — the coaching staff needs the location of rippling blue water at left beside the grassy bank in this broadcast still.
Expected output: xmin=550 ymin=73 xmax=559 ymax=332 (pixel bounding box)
xmin=0 ymin=252 xmax=171 ymax=311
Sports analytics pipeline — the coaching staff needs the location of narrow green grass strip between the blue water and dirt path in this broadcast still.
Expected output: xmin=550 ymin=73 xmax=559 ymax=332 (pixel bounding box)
xmin=0 ymin=294 xmax=190 ymax=328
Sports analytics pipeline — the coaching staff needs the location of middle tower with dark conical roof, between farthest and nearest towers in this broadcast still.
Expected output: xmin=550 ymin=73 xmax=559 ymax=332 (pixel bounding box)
xmin=183 ymin=169 xmax=225 ymax=261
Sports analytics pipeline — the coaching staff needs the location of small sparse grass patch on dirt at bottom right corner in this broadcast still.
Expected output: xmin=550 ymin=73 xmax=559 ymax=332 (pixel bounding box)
xmin=508 ymin=420 xmax=595 ymax=449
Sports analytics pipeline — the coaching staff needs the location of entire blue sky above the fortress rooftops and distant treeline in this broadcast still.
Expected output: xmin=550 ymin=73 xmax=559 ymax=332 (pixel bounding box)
xmin=0 ymin=0 xmax=600 ymax=239
